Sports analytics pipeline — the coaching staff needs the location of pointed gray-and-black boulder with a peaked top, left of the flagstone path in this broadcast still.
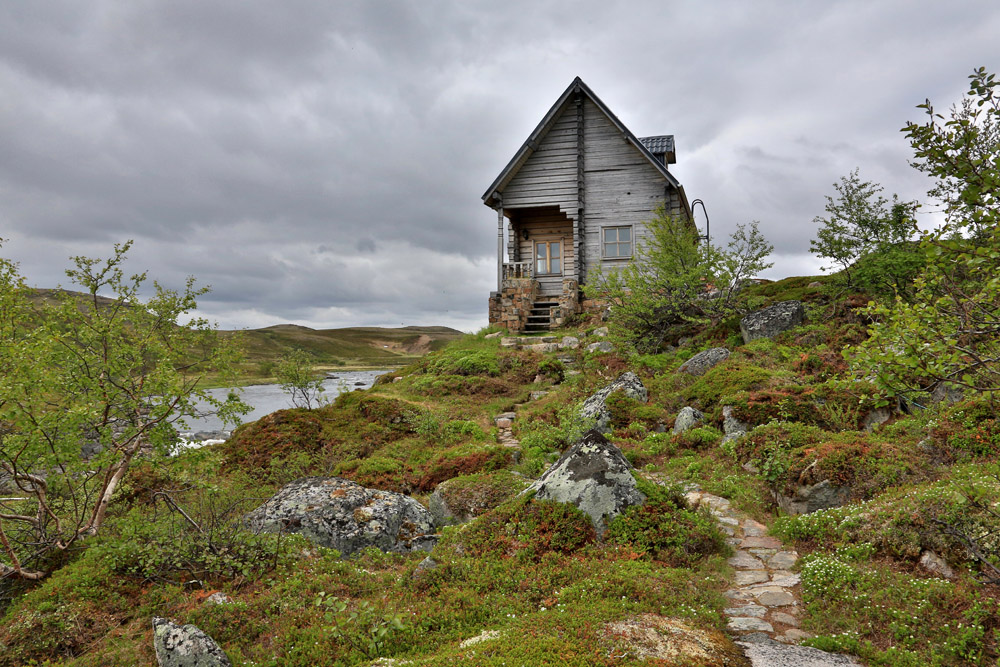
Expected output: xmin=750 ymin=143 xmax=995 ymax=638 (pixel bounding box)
xmin=524 ymin=430 xmax=646 ymax=536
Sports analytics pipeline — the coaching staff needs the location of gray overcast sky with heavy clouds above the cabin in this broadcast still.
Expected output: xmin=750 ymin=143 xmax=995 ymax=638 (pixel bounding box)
xmin=0 ymin=0 xmax=1000 ymax=330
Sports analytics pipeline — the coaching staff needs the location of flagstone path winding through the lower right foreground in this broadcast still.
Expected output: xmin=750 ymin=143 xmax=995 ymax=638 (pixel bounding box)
xmin=686 ymin=489 xmax=812 ymax=644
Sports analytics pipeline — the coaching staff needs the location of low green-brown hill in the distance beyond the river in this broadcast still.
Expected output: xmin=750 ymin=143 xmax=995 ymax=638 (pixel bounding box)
xmin=23 ymin=288 xmax=462 ymax=377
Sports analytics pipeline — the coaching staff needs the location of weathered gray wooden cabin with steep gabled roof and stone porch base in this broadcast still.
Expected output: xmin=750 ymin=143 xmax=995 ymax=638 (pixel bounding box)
xmin=483 ymin=77 xmax=690 ymax=331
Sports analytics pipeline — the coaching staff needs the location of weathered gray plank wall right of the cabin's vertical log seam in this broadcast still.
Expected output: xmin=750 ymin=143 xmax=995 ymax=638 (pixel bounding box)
xmin=581 ymin=99 xmax=679 ymax=282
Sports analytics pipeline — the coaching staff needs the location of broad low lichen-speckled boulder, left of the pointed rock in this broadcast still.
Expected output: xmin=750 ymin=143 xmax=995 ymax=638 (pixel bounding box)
xmin=245 ymin=477 xmax=437 ymax=556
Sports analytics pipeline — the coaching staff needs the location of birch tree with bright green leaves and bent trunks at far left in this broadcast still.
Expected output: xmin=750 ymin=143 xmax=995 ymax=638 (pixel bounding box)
xmin=0 ymin=242 xmax=246 ymax=579
